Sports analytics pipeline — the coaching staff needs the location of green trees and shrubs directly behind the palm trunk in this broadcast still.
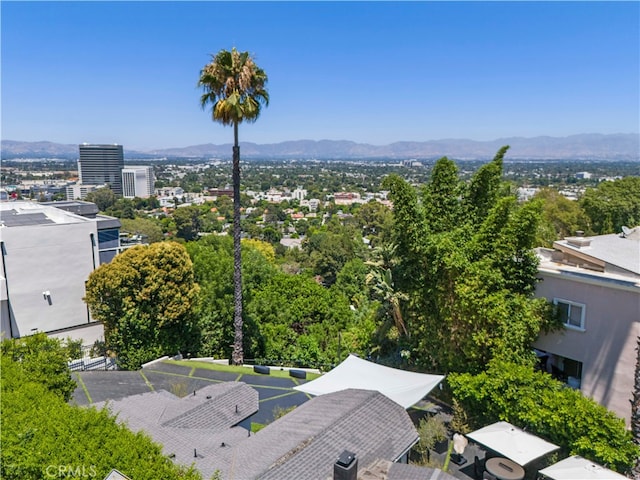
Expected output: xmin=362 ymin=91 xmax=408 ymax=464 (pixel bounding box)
xmin=186 ymin=235 xmax=378 ymax=368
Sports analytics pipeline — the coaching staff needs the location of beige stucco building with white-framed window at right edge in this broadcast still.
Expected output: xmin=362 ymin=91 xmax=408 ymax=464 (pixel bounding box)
xmin=534 ymin=227 xmax=640 ymax=424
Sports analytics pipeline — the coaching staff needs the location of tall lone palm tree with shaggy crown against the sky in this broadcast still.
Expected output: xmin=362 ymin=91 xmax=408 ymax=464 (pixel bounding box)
xmin=198 ymin=48 xmax=269 ymax=365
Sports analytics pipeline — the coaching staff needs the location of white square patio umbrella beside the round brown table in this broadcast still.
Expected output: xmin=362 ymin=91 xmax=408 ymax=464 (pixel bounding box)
xmin=467 ymin=422 xmax=560 ymax=465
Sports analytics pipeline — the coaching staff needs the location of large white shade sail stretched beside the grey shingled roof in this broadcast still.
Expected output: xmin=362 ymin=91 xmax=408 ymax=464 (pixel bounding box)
xmin=294 ymin=355 xmax=444 ymax=408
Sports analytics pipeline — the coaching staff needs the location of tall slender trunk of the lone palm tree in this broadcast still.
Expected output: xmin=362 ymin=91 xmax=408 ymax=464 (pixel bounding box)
xmin=231 ymin=122 xmax=244 ymax=365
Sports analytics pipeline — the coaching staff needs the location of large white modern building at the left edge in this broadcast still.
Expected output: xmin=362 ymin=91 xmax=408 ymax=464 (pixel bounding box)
xmin=0 ymin=202 xmax=103 ymax=344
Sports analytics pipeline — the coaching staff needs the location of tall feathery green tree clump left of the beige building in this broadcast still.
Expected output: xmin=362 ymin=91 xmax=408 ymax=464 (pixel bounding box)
xmin=385 ymin=147 xmax=554 ymax=372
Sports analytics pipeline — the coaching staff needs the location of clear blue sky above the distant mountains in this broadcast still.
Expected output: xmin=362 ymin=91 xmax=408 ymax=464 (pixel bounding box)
xmin=0 ymin=0 xmax=640 ymax=150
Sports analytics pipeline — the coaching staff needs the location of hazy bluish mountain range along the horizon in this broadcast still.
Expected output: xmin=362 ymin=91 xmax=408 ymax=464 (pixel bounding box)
xmin=1 ymin=133 xmax=640 ymax=161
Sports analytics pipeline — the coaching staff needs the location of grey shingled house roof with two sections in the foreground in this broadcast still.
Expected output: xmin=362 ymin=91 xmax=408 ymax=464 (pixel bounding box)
xmin=99 ymin=382 xmax=424 ymax=480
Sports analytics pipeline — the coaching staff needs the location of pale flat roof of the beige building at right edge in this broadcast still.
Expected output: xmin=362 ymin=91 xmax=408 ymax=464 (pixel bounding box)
xmin=553 ymin=227 xmax=640 ymax=275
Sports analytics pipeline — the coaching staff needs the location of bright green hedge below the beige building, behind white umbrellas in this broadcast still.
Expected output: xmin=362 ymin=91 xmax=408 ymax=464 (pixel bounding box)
xmin=447 ymin=360 xmax=640 ymax=472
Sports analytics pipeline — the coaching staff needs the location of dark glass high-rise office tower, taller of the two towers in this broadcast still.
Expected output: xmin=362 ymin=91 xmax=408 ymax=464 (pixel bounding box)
xmin=78 ymin=143 xmax=124 ymax=195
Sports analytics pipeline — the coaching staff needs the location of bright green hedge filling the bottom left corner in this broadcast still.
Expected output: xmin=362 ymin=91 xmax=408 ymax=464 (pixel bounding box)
xmin=0 ymin=334 xmax=201 ymax=480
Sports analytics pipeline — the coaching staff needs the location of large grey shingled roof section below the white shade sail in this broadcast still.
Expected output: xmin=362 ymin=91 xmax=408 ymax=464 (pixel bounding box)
xmin=223 ymin=389 xmax=418 ymax=480
